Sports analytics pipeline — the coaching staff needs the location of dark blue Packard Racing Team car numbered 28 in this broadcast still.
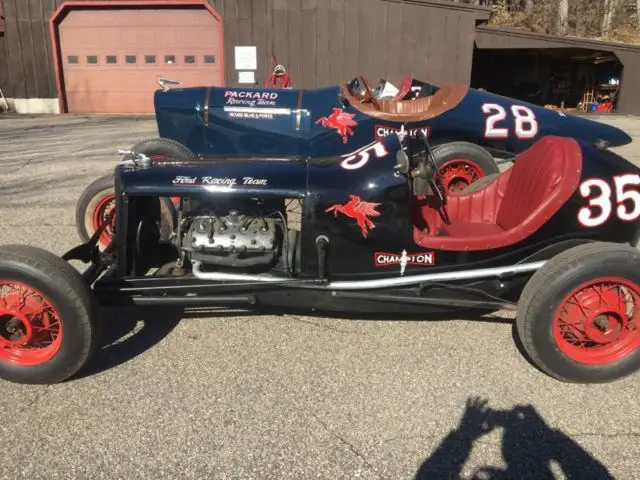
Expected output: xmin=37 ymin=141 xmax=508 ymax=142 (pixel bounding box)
xmin=76 ymin=76 xmax=631 ymax=248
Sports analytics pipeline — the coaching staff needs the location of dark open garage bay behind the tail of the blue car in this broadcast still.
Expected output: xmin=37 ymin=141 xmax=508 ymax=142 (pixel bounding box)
xmin=471 ymin=48 xmax=623 ymax=113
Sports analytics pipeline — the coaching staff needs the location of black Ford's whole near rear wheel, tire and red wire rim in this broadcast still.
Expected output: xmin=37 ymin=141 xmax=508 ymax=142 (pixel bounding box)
xmin=516 ymin=243 xmax=640 ymax=383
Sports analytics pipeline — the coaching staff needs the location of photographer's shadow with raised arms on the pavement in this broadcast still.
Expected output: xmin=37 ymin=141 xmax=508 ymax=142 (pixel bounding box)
xmin=415 ymin=398 xmax=614 ymax=480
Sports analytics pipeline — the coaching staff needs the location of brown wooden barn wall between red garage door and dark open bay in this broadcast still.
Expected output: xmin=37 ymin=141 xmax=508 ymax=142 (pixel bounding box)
xmin=216 ymin=0 xmax=477 ymax=88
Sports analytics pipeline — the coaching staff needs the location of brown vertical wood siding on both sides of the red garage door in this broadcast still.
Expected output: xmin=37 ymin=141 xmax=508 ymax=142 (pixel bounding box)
xmin=0 ymin=0 xmax=488 ymax=98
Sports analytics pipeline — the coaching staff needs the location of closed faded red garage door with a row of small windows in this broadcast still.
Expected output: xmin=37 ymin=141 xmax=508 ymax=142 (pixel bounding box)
xmin=58 ymin=8 xmax=224 ymax=113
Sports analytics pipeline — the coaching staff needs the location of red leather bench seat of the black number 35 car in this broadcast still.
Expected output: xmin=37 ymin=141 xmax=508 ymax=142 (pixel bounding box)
xmin=414 ymin=136 xmax=582 ymax=251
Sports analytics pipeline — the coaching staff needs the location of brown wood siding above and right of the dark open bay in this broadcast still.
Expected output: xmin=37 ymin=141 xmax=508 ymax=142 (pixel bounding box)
xmin=475 ymin=26 xmax=640 ymax=115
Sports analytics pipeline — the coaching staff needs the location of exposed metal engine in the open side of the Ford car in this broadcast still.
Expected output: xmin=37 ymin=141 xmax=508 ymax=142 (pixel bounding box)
xmin=179 ymin=200 xmax=286 ymax=267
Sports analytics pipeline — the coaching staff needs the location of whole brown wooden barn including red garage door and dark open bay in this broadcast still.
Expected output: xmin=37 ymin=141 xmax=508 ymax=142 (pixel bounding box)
xmin=0 ymin=0 xmax=640 ymax=114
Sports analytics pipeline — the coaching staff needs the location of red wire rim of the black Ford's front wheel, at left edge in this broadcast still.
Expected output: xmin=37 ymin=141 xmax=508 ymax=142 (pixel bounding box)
xmin=0 ymin=281 xmax=63 ymax=367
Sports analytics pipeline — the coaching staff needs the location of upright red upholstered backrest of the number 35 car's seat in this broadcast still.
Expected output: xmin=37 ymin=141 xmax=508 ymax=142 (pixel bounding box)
xmin=496 ymin=137 xmax=582 ymax=230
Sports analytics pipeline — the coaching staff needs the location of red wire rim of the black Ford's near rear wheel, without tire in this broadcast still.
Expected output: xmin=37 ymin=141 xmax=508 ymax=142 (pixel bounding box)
xmin=552 ymin=277 xmax=640 ymax=365
